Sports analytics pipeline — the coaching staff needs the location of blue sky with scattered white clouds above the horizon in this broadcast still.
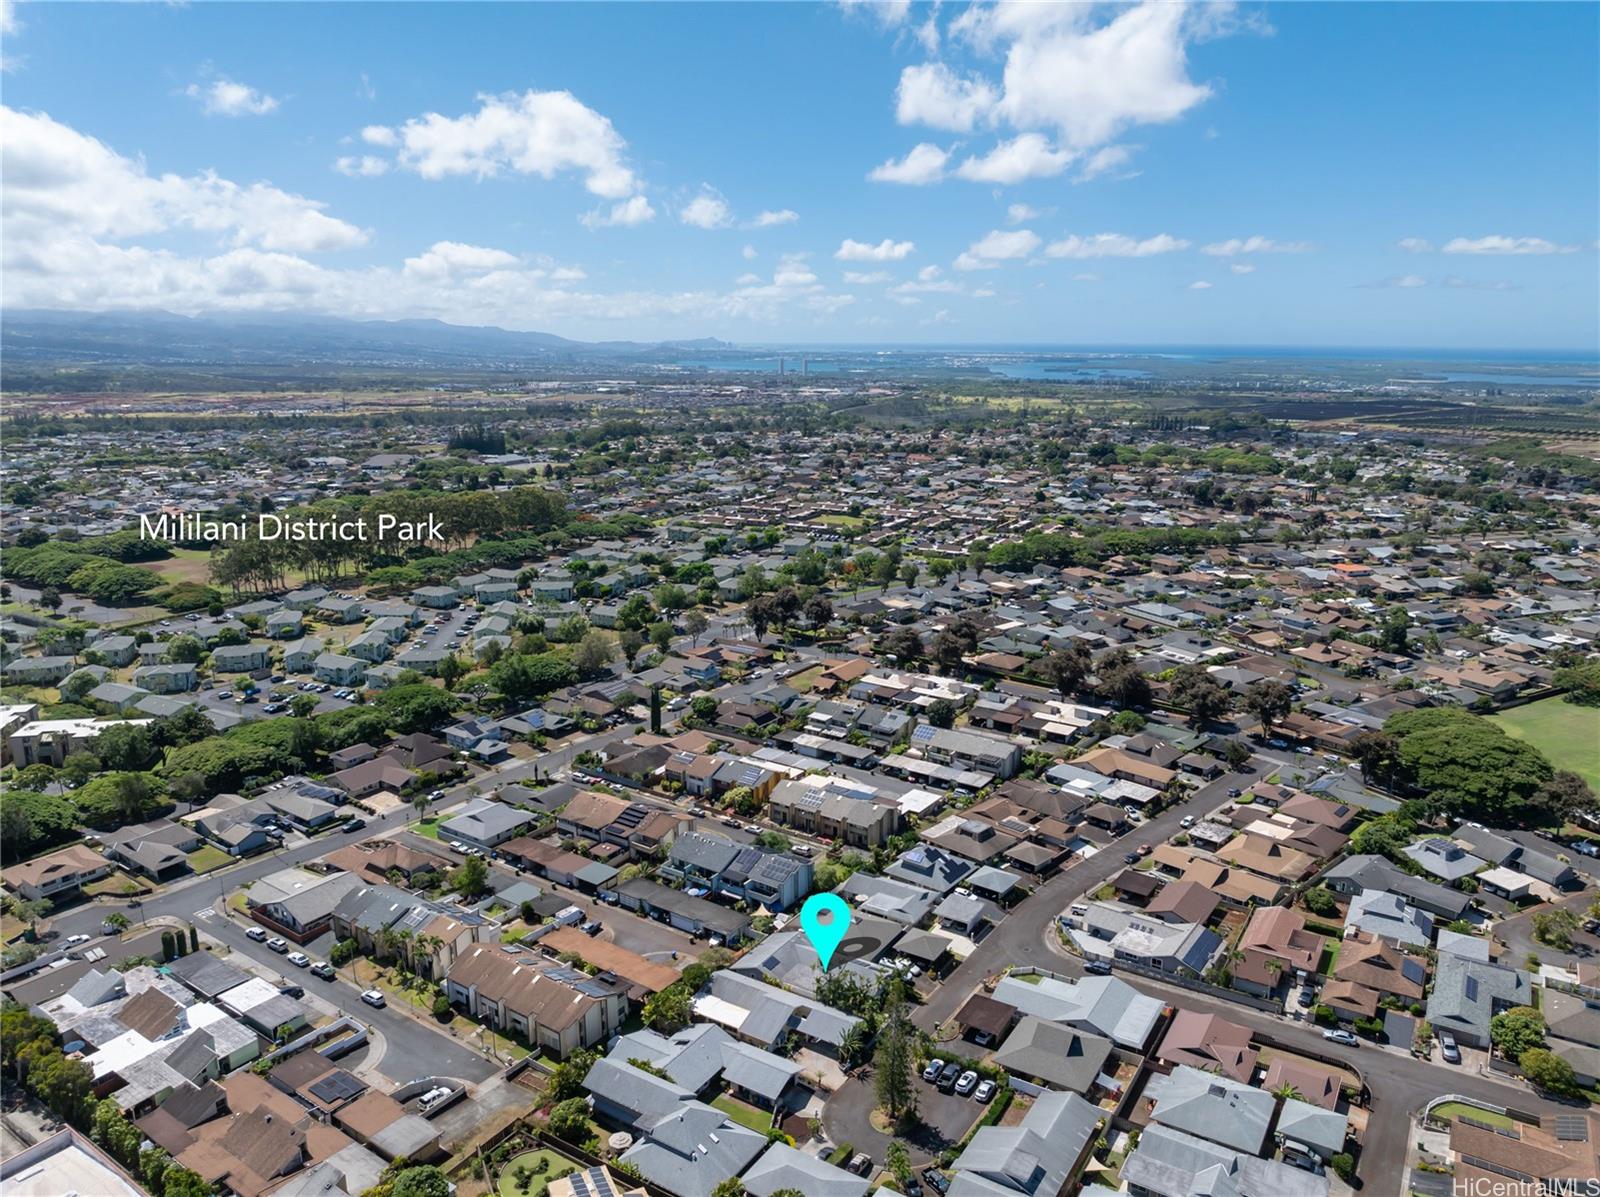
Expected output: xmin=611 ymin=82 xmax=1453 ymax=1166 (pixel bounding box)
xmin=0 ymin=3 xmax=1600 ymax=350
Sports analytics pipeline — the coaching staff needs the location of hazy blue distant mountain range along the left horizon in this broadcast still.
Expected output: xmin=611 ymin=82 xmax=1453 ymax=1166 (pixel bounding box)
xmin=0 ymin=310 xmax=733 ymax=368
